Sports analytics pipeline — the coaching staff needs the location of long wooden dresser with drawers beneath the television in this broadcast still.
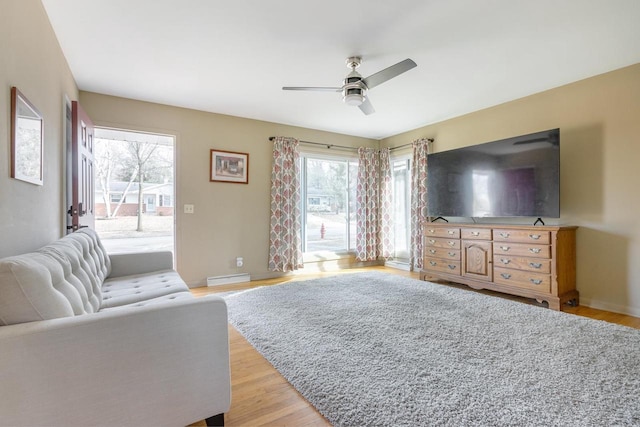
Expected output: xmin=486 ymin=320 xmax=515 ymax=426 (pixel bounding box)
xmin=420 ymin=223 xmax=579 ymax=310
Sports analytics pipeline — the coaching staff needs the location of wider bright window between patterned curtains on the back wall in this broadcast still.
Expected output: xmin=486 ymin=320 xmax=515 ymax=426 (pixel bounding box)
xmin=300 ymin=154 xmax=358 ymax=252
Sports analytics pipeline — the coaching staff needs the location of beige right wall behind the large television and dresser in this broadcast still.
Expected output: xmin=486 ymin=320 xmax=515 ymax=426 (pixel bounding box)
xmin=381 ymin=64 xmax=640 ymax=316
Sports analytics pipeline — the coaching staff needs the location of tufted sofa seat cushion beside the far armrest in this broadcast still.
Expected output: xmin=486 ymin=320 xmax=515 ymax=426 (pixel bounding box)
xmin=100 ymin=270 xmax=189 ymax=310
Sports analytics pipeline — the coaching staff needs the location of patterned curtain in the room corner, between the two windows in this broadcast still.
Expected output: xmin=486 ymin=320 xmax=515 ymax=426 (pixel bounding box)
xmin=356 ymin=147 xmax=393 ymax=261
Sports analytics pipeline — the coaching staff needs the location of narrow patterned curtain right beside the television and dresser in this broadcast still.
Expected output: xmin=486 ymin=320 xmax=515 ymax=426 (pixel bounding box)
xmin=409 ymin=138 xmax=429 ymax=271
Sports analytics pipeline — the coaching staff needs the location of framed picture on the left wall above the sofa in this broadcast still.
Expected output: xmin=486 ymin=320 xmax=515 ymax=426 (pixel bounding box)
xmin=11 ymin=86 xmax=44 ymax=185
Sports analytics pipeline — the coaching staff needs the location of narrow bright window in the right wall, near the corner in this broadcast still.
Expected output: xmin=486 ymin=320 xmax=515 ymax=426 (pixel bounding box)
xmin=391 ymin=157 xmax=411 ymax=262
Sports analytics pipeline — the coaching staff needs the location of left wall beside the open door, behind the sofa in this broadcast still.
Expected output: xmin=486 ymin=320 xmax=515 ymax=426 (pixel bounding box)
xmin=0 ymin=0 xmax=78 ymax=257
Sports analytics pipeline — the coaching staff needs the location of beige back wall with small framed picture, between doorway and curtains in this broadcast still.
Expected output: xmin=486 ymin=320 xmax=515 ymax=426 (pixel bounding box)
xmin=80 ymin=92 xmax=378 ymax=286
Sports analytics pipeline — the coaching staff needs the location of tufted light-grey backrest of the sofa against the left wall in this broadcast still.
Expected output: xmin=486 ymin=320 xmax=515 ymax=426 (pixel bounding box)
xmin=0 ymin=228 xmax=111 ymax=325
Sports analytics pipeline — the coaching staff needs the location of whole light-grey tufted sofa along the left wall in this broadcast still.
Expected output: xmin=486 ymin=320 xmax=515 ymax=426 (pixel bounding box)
xmin=0 ymin=229 xmax=231 ymax=426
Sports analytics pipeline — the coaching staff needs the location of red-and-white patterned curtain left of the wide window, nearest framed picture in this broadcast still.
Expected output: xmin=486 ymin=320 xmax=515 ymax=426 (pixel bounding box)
xmin=269 ymin=137 xmax=304 ymax=271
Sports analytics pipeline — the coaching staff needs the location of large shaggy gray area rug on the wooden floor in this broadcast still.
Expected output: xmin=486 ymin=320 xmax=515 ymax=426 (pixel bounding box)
xmin=226 ymin=272 xmax=640 ymax=426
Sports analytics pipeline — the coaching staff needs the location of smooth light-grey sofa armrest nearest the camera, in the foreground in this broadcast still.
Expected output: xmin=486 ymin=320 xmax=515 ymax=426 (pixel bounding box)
xmin=0 ymin=296 xmax=231 ymax=426
